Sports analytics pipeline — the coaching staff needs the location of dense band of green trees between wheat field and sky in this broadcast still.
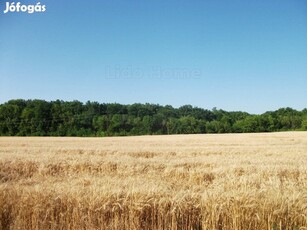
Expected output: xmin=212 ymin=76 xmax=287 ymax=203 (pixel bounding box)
xmin=0 ymin=99 xmax=307 ymax=136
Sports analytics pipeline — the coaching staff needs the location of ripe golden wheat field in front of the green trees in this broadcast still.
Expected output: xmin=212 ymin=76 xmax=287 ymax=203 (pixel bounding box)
xmin=0 ymin=132 xmax=307 ymax=229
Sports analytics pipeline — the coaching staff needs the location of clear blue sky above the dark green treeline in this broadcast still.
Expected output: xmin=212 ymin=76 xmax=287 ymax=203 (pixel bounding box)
xmin=0 ymin=0 xmax=307 ymax=113
